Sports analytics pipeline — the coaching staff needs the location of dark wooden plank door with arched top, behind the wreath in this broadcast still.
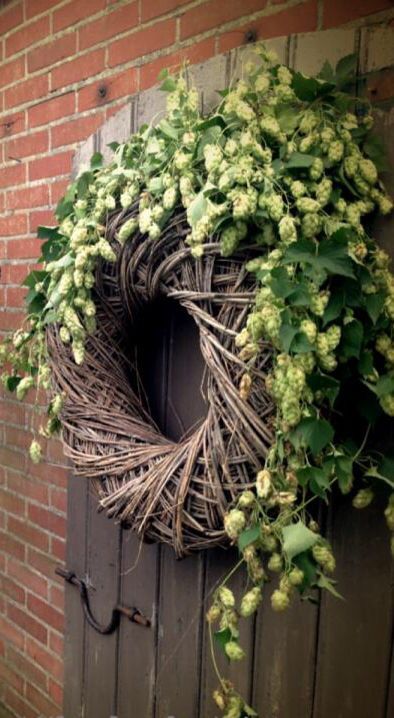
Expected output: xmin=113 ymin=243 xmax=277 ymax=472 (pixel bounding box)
xmin=64 ymin=29 xmax=394 ymax=718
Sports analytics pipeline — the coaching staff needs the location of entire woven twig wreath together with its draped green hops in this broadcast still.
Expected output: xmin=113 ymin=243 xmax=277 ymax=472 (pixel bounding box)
xmin=1 ymin=46 xmax=394 ymax=718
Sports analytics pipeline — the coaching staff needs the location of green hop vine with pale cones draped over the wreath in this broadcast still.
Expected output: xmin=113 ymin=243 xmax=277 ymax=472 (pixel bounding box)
xmin=0 ymin=46 xmax=394 ymax=718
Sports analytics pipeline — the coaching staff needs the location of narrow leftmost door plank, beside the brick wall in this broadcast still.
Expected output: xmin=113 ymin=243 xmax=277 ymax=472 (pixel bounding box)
xmin=64 ymin=476 xmax=88 ymax=718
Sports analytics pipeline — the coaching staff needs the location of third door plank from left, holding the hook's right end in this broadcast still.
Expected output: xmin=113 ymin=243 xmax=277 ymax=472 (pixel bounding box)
xmin=117 ymin=531 xmax=160 ymax=718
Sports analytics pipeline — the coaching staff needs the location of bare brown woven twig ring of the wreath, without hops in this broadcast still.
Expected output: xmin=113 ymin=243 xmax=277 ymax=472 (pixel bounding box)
xmin=49 ymin=210 xmax=273 ymax=556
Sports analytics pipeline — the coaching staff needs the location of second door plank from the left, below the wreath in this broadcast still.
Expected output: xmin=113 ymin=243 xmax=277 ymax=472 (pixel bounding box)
xmin=85 ymin=495 xmax=120 ymax=718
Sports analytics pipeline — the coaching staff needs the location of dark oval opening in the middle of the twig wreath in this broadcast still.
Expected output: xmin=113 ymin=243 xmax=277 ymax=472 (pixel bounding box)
xmin=136 ymin=296 xmax=208 ymax=442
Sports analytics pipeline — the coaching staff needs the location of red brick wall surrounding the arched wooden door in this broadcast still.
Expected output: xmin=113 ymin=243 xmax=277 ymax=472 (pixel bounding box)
xmin=0 ymin=0 xmax=392 ymax=718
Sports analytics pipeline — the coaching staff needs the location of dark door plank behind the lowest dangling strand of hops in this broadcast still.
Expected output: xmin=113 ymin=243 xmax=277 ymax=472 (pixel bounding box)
xmin=199 ymin=549 xmax=254 ymax=718
